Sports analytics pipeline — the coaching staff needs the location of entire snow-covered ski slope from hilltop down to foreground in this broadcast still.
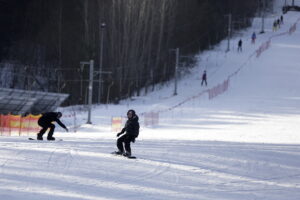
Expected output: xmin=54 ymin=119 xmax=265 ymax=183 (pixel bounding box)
xmin=0 ymin=1 xmax=300 ymax=200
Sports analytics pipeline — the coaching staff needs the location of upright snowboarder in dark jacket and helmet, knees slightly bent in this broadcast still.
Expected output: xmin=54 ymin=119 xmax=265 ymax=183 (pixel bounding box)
xmin=116 ymin=110 xmax=140 ymax=156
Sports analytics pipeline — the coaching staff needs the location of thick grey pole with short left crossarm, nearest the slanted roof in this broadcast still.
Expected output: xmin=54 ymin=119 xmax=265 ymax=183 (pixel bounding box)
xmin=80 ymin=60 xmax=94 ymax=124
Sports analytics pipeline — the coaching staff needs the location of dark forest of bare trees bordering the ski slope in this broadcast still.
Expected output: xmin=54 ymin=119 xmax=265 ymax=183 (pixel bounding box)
xmin=0 ymin=0 xmax=272 ymax=104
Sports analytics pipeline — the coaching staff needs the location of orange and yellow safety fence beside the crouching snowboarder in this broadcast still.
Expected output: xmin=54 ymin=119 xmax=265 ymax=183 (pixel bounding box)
xmin=0 ymin=115 xmax=41 ymax=136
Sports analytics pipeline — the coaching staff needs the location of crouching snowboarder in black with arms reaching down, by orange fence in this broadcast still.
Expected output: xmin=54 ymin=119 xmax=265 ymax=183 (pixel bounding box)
xmin=37 ymin=112 xmax=68 ymax=140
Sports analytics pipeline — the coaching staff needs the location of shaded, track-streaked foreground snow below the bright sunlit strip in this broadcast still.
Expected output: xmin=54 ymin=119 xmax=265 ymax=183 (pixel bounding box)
xmin=0 ymin=138 xmax=300 ymax=199
